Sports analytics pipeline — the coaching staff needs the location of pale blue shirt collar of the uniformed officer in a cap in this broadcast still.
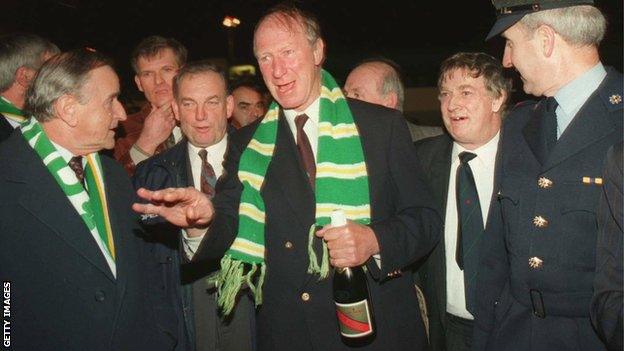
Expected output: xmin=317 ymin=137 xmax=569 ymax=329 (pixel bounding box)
xmin=555 ymin=62 xmax=607 ymax=115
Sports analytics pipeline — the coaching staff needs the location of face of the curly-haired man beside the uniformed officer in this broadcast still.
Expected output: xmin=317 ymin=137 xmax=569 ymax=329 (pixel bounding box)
xmin=439 ymin=68 xmax=505 ymax=150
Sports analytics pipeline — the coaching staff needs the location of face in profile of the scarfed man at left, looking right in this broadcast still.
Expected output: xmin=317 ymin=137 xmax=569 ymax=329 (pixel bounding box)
xmin=75 ymin=66 xmax=126 ymax=155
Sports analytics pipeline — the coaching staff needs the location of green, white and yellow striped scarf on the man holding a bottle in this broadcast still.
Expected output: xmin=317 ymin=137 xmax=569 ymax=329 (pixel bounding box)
xmin=213 ymin=70 xmax=370 ymax=315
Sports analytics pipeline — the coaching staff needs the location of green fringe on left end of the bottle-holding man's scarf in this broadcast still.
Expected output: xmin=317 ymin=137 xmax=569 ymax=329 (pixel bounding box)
xmin=208 ymin=255 xmax=266 ymax=316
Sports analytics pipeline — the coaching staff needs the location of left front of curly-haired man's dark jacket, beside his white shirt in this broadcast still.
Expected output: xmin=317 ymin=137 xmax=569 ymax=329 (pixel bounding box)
xmin=414 ymin=134 xmax=502 ymax=350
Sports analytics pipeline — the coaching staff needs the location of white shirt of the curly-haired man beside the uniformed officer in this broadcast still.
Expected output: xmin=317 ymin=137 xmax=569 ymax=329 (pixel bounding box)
xmin=444 ymin=133 xmax=500 ymax=319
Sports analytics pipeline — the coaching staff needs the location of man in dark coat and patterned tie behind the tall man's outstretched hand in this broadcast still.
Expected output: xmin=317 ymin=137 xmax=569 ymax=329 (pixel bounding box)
xmin=133 ymin=61 xmax=254 ymax=351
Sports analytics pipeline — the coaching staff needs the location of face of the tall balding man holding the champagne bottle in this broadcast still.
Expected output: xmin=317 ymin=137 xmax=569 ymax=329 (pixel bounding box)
xmin=254 ymin=14 xmax=324 ymax=111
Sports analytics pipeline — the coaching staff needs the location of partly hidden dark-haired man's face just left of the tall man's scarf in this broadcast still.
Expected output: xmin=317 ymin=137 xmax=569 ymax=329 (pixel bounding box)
xmin=231 ymin=80 xmax=266 ymax=129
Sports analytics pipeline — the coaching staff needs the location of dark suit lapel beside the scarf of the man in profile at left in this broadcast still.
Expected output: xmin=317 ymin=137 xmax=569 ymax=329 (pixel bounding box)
xmin=9 ymin=141 xmax=115 ymax=281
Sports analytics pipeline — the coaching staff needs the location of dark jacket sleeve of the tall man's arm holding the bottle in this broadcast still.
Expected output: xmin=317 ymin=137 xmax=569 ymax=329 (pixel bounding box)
xmin=367 ymin=112 xmax=440 ymax=279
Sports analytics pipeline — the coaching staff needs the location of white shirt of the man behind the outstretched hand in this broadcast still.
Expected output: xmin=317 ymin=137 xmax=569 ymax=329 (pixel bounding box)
xmin=182 ymin=135 xmax=227 ymax=259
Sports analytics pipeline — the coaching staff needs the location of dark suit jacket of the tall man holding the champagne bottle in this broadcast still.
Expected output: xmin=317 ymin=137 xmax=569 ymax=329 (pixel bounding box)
xmin=198 ymin=100 xmax=439 ymax=350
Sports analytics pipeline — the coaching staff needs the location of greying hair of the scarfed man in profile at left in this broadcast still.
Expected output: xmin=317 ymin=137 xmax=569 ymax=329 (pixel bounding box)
xmin=24 ymin=49 xmax=113 ymax=122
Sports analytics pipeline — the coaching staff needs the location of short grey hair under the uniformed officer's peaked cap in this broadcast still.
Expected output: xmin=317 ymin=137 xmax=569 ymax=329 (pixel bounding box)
xmin=519 ymin=5 xmax=607 ymax=47
